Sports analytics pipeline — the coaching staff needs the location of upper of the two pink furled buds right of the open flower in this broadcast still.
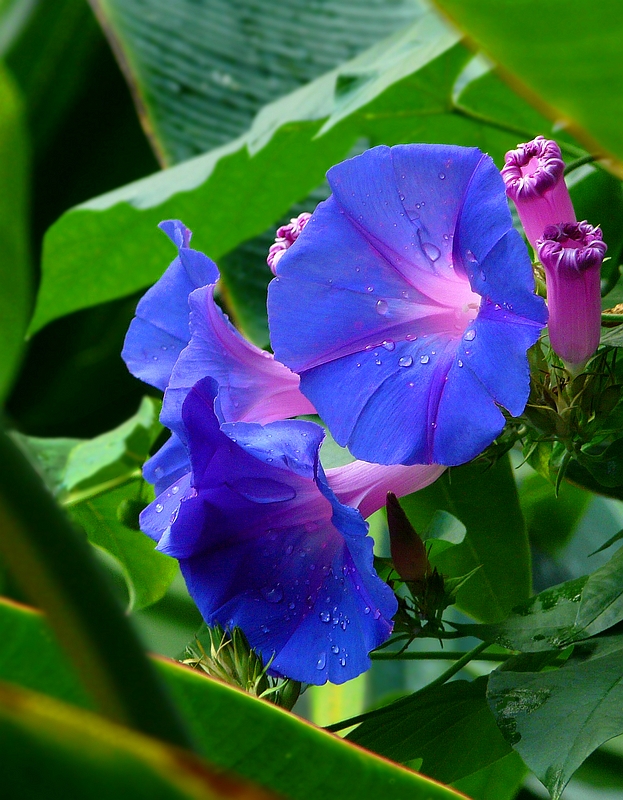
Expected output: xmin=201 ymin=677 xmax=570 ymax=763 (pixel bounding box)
xmin=502 ymin=136 xmax=576 ymax=250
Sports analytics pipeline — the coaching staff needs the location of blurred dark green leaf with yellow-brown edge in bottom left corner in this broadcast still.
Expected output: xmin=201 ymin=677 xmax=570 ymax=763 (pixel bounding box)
xmin=0 ymin=685 xmax=270 ymax=800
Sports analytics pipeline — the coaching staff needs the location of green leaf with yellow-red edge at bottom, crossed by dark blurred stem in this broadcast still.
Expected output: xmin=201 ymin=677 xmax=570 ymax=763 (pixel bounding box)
xmin=0 ymin=601 xmax=468 ymax=800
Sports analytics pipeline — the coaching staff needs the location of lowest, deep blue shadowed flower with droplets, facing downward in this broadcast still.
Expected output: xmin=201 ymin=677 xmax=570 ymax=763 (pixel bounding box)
xmin=141 ymin=378 xmax=397 ymax=684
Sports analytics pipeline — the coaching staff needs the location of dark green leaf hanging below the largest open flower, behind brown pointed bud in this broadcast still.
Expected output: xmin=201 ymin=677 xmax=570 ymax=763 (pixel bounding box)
xmin=401 ymin=457 xmax=531 ymax=622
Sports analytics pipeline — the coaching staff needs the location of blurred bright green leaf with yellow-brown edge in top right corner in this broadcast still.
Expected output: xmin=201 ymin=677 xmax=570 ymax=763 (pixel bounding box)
xmin=437 ymin=0 xmax=623 ymax=174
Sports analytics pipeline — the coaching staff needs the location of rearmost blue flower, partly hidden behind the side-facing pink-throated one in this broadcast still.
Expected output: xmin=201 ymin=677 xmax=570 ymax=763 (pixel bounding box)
xmin=121 ymin=220 xmax=219 ymax=391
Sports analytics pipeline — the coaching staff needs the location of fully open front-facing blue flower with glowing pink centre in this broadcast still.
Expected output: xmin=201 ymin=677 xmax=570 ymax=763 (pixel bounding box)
xmin=268 ymin=145 xmax=547 ymax=465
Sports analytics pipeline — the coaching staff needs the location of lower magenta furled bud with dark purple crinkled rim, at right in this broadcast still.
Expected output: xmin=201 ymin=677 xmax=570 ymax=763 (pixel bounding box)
xmin=537 ymin=222 xmax=607 ymax=374
